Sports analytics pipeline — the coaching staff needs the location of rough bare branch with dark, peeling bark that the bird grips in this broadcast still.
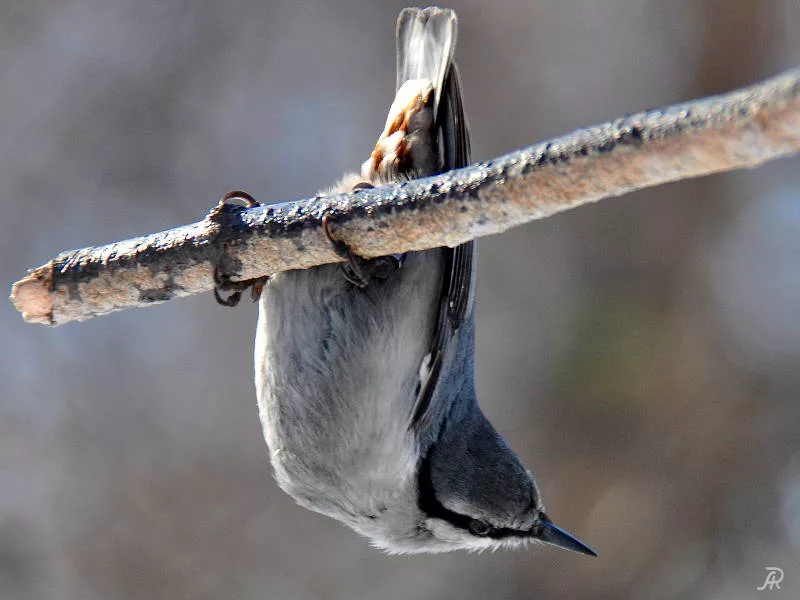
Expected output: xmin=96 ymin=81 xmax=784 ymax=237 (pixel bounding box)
xmin=11 ymin=68 xmax=800 ymax=325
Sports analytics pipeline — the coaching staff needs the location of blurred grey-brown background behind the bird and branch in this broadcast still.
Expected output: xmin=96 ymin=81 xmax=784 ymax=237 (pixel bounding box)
xmin=0 ymin=0 xmax=800 ymax=600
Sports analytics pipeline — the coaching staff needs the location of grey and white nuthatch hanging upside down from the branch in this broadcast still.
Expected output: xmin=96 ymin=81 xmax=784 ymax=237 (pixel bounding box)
xmin=222 ymin=8 xmax=594 ymax=555
